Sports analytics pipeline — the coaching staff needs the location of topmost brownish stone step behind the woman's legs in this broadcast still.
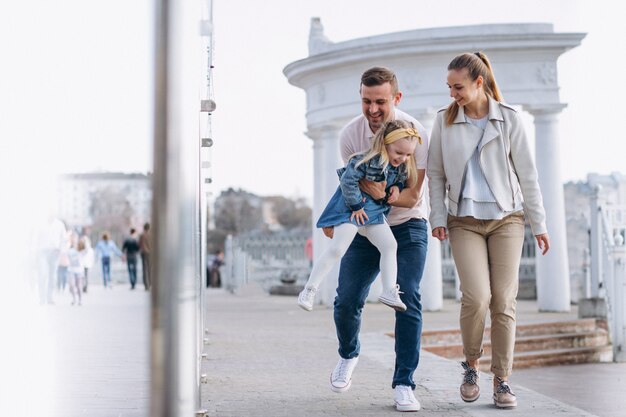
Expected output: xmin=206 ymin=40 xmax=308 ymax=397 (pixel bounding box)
xmin=422 ymin=319 xmax=607 ymax=346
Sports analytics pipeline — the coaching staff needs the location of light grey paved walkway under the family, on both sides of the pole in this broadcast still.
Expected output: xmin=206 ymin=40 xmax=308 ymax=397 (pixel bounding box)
xmin=40 ymin=284 xmax=626 ymax=417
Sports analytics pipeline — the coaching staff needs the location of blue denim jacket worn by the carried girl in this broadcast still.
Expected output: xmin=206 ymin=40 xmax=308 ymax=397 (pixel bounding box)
xmin=337 ymin=153 xmax=407 ymax=211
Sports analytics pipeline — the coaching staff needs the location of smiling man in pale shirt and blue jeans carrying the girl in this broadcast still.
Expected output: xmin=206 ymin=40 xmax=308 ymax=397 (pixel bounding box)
xmin=324 ymin=67 xmax=428 ymax=411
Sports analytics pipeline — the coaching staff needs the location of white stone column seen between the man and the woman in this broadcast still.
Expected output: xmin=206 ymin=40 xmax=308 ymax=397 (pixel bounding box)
xmin=415 ymin=109 xmax=443 ymax=311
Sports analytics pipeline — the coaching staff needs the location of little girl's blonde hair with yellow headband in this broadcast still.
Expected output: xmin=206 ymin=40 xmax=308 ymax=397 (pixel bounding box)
xmin=352 ymin=120 xmax=422 ymax=188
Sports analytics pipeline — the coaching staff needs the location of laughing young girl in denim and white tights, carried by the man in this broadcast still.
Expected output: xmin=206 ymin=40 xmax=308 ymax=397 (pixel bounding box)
xmin=298 ymin=120 xmax=422 ymax=311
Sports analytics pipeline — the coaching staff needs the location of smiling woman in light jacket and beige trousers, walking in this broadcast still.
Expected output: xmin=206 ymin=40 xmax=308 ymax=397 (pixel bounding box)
xmin=427 ymin=52 xmax=550 ymax=408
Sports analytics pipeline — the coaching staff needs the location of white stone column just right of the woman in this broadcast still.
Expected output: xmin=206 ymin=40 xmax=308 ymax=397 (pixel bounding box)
xmin=528 ymin=103 xmax=570 ymax=312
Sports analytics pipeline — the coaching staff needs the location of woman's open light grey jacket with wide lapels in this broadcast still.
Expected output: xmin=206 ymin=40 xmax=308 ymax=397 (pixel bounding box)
xmin=426 ymin=97 xmax=547 ymax=235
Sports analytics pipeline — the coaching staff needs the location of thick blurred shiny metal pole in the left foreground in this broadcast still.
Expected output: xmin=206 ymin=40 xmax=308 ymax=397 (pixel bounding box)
xmin=150 ymin=0 xmax=200 ymax=417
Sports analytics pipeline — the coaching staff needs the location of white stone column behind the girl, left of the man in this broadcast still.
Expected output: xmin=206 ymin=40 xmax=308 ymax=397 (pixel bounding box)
xmin=307 ymin=125 xmax=343 ymax=306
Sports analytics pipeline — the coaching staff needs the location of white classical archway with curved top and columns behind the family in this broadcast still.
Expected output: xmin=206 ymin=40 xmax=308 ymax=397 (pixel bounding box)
xmin=284 ymin=18 xmax=585 ymax=311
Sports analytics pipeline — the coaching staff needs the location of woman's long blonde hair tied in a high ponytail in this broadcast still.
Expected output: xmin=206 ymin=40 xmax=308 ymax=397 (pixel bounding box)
xmin=446 ymin=52 xmax=502 ymax=124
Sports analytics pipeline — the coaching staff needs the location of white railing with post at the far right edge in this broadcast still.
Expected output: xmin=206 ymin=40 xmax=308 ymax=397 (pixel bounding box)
xmin=588 ymin=186 xmax=626 ymax=362
